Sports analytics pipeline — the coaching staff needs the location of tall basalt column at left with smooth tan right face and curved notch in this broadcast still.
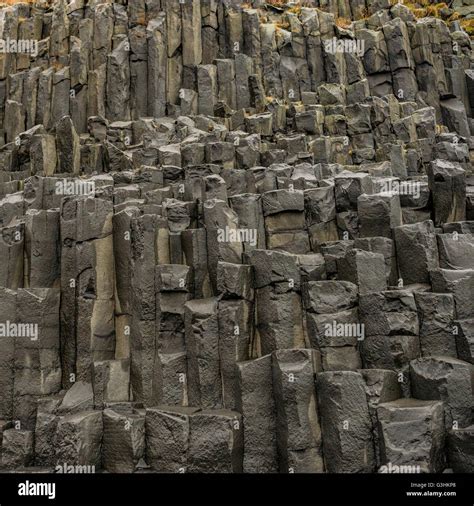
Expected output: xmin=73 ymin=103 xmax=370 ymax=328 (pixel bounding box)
xmin=60 ymin=197 xmax=115 ymax=388
